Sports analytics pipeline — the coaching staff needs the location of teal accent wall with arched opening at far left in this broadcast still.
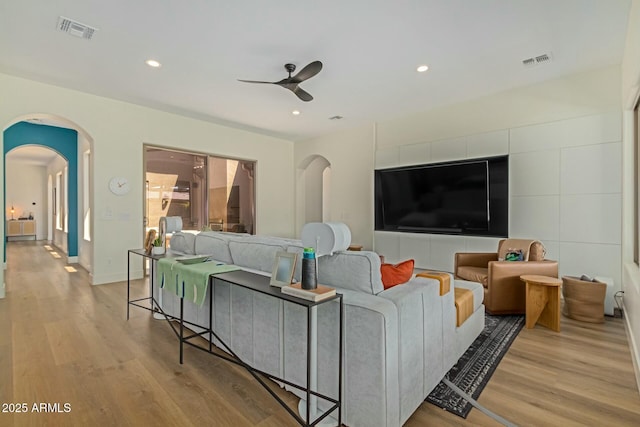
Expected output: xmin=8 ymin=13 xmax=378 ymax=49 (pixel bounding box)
xmin=2 ymin=122 xmax=79 ymax=261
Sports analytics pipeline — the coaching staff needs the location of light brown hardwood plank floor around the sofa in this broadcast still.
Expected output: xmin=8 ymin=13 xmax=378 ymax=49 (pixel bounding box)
xmin=0 ymin=242 xmax=640 ymax=427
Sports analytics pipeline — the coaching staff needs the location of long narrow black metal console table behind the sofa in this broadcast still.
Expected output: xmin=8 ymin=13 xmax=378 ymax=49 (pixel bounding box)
xmin=127 ymin=249 xmax=344 ymax=426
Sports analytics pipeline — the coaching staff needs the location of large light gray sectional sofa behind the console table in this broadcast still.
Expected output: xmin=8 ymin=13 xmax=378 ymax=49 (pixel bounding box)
xmin=154 ymin=232 xmax=484 ymax=427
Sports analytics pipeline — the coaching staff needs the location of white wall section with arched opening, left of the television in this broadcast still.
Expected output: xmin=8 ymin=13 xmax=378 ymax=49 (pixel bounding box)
xmin=294 ymin=125 xmax=374 ymax=249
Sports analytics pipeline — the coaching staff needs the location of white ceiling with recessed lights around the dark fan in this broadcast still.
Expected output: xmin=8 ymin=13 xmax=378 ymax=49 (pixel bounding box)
xmin=0 ymin=0 xmax=631 ymax=141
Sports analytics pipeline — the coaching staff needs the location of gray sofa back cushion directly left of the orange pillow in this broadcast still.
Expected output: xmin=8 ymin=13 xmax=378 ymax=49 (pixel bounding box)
xmin=318 ymin=251 xmax=384 ymax=295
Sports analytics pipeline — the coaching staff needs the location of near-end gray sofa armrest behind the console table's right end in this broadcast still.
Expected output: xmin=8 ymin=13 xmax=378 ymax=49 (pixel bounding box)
xmin=283 ymin=287 xmax=400 ymax=427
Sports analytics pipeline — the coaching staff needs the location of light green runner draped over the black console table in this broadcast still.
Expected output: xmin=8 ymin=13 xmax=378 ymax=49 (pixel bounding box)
xmin=158 ymin=258 xmax=240 ymax=305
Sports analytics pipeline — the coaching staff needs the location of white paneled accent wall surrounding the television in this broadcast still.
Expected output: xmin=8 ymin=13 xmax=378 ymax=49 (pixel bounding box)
xmin=374 ymin=112 xmax=622 ymax=287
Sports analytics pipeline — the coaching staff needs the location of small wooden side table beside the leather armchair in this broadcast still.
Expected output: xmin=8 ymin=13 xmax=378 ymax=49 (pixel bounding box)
xmin=520 ymin=274 xmax=562 ymax=332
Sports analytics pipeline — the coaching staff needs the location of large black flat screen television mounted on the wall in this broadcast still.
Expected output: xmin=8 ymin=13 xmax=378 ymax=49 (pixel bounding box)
xmin=375 ymin=156 xmax=508 ymax=237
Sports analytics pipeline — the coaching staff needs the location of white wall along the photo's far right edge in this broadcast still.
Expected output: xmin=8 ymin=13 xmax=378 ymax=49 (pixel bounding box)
xmin=621 ymin=0 xmax=640 ymax=392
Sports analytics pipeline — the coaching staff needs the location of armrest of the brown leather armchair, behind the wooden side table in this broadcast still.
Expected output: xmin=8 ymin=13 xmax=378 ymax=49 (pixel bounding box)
xmin=485 ymin=260 xmax=558 ymax=314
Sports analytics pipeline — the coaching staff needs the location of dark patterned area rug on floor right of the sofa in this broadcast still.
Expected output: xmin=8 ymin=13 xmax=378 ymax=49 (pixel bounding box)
xmin=425 ymin=314 xmax=525 ymax=418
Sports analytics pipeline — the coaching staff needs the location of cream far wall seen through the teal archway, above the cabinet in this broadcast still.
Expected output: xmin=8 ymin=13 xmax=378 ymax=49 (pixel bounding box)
xmin=6 ymin=160 xmax=47 ymax=240
